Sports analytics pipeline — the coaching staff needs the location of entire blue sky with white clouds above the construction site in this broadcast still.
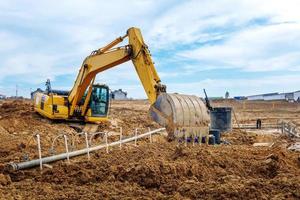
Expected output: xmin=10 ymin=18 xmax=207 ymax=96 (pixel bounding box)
xmin=0 ymin=0 xmax=300 ymax=98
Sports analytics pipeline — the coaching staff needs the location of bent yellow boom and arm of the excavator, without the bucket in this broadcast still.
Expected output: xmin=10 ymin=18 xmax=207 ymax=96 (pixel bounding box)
xmin=68 ymin=28 xmax=166 ymax=115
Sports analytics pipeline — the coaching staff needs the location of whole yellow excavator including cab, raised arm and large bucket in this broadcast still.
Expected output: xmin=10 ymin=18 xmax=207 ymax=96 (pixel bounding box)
xmin=34 ymin=27 xmax=209 ymax=137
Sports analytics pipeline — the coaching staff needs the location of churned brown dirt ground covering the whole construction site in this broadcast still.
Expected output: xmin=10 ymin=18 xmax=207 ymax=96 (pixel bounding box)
xmin=0 ymin=100 xmax=300 ymax=199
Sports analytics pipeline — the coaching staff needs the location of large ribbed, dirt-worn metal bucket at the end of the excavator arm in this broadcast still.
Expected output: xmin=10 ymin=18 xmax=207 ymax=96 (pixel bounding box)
xmin=150 ymin=93 xmax=209 ymax=139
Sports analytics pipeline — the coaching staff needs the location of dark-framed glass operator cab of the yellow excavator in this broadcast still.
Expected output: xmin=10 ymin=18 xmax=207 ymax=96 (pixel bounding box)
xmin=90 ymin=85 xmax=109 ymax=117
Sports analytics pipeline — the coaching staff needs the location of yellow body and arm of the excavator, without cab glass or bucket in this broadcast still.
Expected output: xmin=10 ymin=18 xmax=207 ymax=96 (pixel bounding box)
xmin=34 ymin=28 xmax=166 ymax=122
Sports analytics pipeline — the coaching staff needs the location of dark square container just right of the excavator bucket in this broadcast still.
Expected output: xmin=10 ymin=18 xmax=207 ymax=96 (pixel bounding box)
xmin=210 ymin=107 xmax=232 ymax=133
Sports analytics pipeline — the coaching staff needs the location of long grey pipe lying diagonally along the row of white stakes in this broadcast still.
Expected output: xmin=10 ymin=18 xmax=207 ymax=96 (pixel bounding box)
xmin=7 ymin=128 xmax=165 ymax=171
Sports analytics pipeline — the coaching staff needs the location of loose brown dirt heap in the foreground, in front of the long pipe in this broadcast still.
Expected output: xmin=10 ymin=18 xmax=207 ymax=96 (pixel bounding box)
xmin=2 ymin=142 xmax=300 ymax=199
